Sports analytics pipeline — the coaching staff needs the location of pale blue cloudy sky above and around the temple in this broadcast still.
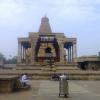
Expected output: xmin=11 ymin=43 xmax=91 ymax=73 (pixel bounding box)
xmin=0 ymin=0 xmax=100 ymax=58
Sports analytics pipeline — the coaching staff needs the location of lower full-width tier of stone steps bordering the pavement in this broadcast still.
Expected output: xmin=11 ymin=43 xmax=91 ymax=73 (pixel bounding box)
xmin=0 ymin=69 xmax=100 ymax=80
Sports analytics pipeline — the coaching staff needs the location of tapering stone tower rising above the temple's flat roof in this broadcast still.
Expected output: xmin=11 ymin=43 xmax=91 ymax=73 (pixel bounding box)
xmin=39 ymin=16 xmax=52 ymax=34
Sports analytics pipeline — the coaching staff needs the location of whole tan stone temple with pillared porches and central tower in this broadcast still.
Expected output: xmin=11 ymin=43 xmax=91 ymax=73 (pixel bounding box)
xmin=17 ymin=16 xmax=77 ymax=65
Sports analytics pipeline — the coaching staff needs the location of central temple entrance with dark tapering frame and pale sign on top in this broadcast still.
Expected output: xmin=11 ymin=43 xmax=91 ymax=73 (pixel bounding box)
xmin=35 ymin=35 xmax=60 ymax=62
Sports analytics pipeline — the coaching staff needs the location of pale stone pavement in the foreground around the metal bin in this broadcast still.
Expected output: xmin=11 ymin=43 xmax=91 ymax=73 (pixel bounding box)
xmin=0 ymin=80 xmax=100 ymax=100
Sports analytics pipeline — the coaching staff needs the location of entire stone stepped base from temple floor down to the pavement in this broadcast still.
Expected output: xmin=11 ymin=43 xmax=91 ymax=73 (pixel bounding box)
xmin=0 ymin=63 xmax=100 ymax=80
